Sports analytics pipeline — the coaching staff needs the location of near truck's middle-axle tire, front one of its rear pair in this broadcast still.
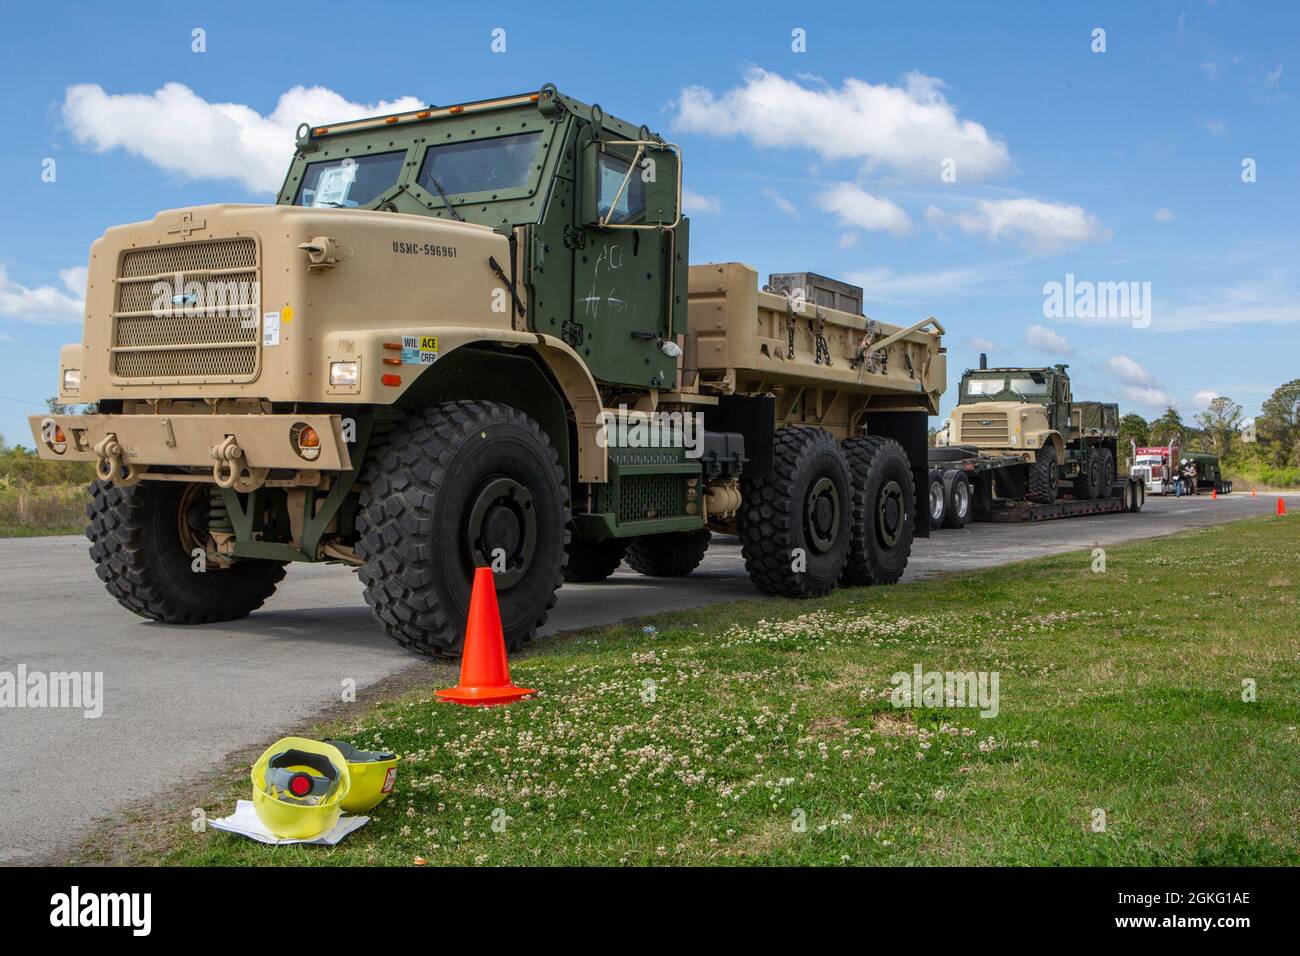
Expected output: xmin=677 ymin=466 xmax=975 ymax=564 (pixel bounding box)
xmin=737 ymin=425 xmax=854 ymax=597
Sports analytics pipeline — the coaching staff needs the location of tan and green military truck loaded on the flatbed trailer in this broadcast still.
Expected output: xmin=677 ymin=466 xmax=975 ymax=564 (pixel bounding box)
xmin=943 ymin=355 xmax=1119 ymax=503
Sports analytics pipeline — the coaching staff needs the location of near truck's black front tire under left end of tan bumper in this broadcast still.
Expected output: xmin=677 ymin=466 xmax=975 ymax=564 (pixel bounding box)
xmin=86 ymin=481 xmax=285 ymax=624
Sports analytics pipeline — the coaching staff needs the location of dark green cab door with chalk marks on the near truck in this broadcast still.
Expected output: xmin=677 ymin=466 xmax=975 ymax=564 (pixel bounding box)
xmin=577 ymin=147 xmax=685 ymax=388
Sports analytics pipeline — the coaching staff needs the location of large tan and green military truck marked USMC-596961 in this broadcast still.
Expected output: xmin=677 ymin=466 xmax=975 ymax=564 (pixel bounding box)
xmin=31 ymin=85 xmax=946 ymax=654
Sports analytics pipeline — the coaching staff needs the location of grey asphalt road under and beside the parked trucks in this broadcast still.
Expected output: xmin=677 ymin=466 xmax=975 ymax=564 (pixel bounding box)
xmin=0 ymin=493 xmax=1279 ymax=864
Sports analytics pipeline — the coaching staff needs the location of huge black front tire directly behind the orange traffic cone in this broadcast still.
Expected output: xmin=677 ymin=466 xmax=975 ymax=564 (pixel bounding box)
xmin=356 ymin=402 xmax=569 ymax=656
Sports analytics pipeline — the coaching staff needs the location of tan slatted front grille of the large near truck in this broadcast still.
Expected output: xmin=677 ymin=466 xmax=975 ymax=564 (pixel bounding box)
xmin=112 ymin=238 xmax=261 ymax=384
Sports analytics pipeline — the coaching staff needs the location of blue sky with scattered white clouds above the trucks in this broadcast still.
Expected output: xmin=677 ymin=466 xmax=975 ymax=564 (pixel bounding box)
xmin=0 ymin=0 xmax=1300 ymax=444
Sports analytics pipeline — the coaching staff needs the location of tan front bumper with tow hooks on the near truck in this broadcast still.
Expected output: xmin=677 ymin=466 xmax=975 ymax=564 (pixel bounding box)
xmin=27 ymin=415 xmax=352 ymax=477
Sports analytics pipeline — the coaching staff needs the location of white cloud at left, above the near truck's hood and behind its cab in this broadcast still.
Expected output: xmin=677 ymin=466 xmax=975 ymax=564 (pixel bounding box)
xmin=64 ymin=83 xmax=425 ymax=193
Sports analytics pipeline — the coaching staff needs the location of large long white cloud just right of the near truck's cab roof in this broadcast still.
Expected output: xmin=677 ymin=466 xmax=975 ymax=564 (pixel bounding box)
xmin=675 ymin=66 xmax=1011 ymax=181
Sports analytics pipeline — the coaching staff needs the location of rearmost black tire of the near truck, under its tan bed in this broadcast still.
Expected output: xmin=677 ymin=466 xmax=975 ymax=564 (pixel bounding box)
xmin=840 ymin=436 xmax=920 ymax=588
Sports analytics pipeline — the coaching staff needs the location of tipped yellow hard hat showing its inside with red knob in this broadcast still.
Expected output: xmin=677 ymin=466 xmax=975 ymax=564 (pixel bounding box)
xmin=252 ymin=737 xmax=352 ymax=840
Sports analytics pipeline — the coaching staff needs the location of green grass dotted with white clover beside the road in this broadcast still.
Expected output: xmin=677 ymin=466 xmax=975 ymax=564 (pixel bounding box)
xmin=79 ymin=516 xmax=1300 ymax=865
